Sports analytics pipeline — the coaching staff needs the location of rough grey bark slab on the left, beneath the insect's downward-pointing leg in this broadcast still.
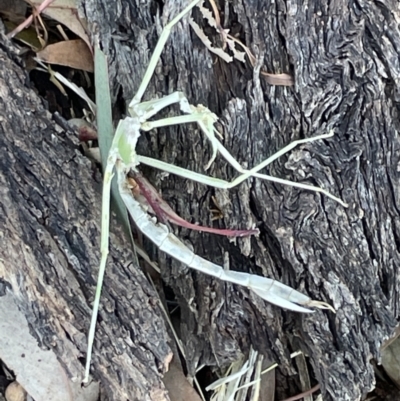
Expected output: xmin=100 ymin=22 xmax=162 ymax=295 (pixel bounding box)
xmin=0 ymin=30 xmax=171 ymax=400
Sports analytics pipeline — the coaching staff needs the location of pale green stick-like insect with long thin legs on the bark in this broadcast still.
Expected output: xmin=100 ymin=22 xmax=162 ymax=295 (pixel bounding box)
xmin=83 ymin=0 xmax=347 ymax=382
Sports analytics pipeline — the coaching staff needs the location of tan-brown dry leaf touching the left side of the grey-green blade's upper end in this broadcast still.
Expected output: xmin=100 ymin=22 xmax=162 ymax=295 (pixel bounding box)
xmin=37 ymin=39 xmax=94 ymax=72
